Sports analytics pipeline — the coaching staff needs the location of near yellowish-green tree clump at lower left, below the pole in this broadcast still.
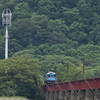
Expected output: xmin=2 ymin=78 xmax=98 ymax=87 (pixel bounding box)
xmin=0 ymin=55 xmax=43 ymax=100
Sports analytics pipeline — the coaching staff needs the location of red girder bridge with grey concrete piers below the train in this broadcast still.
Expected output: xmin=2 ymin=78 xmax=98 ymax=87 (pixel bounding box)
xmin=44 ymin=77 xmax=100 ymax=100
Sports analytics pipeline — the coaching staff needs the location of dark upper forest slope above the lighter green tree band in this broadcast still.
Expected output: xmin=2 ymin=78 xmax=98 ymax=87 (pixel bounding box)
xmin=0 ymin=0 xmax=100 ymax=59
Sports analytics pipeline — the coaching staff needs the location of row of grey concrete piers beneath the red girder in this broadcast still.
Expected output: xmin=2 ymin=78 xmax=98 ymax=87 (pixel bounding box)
xmin=46 ymin=89 xmax=100 ymax=100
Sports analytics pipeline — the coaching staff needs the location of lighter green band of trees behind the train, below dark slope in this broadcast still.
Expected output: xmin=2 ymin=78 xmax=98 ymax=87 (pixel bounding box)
xmin=13 ymin=44 xmax=100 ymax=80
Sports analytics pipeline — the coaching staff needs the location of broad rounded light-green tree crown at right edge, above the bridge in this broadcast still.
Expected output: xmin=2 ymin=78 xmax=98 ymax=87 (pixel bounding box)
xmin=78 ymin=44 xmax=100 ymax=67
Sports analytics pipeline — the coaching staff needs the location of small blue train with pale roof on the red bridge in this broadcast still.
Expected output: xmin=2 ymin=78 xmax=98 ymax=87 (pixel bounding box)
xmin=45 ymin=72 xmax=56 ymax=84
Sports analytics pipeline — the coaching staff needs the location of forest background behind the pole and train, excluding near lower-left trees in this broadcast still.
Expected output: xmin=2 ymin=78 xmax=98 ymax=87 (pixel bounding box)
xmin=0 ymin=0 xmax=100 ymax=97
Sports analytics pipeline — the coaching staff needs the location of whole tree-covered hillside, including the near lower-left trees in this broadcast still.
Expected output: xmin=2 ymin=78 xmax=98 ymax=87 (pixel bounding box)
xmin=0 ymin=0 xmax=100 ymax=100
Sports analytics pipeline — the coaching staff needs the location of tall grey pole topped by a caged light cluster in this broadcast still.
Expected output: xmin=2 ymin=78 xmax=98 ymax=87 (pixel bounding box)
xmin=2 ymin=8 xmax=12 ymax=59
